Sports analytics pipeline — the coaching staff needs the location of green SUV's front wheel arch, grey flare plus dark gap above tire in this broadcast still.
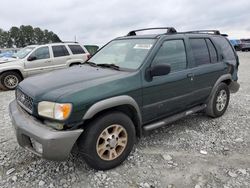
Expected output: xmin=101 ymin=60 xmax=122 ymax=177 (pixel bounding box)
xmin=83 ymin=95 xmax=142 ymax=137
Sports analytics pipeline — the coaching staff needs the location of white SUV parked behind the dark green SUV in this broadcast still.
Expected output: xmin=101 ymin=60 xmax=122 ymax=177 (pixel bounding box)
xmin=0 ymin=43 xmax=90 ymax=90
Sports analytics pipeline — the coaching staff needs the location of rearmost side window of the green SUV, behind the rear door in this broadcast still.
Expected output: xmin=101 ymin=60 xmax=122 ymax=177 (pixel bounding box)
xmin=214 ymin=37 xmax=236 ymax=61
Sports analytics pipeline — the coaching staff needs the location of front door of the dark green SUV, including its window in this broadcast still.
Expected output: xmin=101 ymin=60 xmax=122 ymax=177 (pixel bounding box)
xmin=143 ymin=39 xmax=193 ymax=123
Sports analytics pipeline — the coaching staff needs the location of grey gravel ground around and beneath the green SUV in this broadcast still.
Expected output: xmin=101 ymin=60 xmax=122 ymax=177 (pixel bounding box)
xmin=0 ymin=53 xmax=250 ymax=188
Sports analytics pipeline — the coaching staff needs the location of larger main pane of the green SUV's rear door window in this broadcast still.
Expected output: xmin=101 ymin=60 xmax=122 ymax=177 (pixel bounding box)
xmin=190 ymin=39 xmax=210 ymax=66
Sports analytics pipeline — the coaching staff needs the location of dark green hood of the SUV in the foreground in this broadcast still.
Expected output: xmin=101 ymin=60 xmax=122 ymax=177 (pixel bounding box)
xmin=19 ymin=65 xmax=129 ymax=101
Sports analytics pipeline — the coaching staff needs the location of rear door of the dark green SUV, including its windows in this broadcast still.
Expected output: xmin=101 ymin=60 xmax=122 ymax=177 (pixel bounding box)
xmin=189 ymin=38 xmax=226 ymax=104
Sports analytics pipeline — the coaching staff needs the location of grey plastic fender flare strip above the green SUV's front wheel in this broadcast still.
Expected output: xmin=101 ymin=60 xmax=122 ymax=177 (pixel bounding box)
xmin=83 ymin=95 xmax=142 ymax=125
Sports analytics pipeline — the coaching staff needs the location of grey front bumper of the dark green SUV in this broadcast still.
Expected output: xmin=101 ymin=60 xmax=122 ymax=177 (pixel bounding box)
xmin=9 ymin=101 xmax=83 ymax=160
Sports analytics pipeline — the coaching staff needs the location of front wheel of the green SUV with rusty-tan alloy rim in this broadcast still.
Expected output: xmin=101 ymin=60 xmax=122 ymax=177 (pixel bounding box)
xmin=77 ymin=111 xmax=136 ymax=170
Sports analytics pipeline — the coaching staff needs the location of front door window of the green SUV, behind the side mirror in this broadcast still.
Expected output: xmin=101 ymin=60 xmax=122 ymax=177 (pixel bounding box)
xmin=153 ymin=40 xmax=187 ymax=72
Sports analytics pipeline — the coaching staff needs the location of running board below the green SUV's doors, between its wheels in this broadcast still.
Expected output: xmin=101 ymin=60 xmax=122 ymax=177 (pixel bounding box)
xmin=143 ymin=104 xmax=207 ymax=131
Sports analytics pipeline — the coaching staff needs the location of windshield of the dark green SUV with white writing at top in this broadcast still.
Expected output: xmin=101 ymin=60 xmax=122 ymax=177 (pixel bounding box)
xmin=89 ymin=39 xmax=155 ymax=70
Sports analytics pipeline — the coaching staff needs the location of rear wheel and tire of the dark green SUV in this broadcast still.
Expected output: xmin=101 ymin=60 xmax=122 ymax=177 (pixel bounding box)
xmin=206 ymin=82 xmax=230 ymax=118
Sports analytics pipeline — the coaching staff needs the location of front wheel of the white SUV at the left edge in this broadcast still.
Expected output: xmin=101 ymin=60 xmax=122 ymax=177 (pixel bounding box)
xmin=0 ymin=71 xmax=22 ymax=91
